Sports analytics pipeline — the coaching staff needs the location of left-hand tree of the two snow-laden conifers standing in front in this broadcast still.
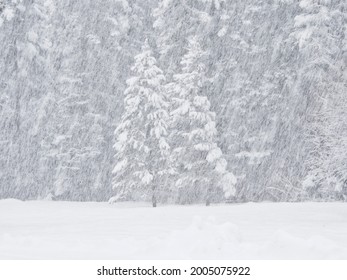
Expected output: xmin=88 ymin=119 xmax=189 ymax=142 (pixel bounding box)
xmin=110 ymin=40 xmax=170 ymax=207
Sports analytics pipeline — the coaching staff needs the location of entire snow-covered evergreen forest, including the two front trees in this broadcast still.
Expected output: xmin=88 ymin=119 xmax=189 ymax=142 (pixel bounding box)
xmin=0 ymin=0 xmax=347 ymax=202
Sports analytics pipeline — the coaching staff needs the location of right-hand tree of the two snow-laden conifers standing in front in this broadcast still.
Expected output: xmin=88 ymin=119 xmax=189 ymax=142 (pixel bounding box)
xmin=168 ymin=37 xmax=236 ymax=205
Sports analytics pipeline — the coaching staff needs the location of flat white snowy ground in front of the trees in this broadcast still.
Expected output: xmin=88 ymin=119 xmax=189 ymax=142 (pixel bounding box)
xmin=0 ymin=200 xmax=347 ymax=259
